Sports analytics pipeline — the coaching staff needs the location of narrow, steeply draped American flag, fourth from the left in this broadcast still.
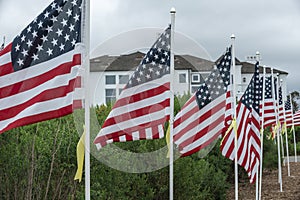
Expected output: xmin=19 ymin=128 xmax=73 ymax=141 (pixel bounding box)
xmin=221 ymin=62 xmax=261 ymax=183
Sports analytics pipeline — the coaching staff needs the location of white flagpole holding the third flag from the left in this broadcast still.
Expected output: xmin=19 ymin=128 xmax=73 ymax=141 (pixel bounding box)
xmin=231 ymin=34 xmax=239 ymax=200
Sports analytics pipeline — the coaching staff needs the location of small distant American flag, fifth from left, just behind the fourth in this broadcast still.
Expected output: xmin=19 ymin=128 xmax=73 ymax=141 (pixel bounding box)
xmin=260 ymin=76 xmax=276 ymax=128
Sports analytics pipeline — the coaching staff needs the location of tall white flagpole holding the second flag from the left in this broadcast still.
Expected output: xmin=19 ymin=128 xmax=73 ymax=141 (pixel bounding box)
xmin=169 ymin=8 xmax=176 ymax=200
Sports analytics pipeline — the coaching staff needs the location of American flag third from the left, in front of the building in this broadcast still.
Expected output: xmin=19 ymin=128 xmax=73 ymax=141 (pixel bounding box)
xmin=173 ymin=48 xmax=231 ymax=156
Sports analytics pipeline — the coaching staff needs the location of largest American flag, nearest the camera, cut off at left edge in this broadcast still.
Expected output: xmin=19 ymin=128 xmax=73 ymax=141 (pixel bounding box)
xmin=0 ymin=0 xmax=83 ymax=133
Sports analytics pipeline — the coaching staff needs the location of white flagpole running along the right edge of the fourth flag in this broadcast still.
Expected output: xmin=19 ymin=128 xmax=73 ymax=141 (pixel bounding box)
xmin=258 ymin=66 xmax=266 ymax=200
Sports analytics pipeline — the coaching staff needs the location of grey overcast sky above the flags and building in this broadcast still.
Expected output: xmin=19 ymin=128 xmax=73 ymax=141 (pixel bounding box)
xmin=0 ymin=0 xmax=300 ymax=91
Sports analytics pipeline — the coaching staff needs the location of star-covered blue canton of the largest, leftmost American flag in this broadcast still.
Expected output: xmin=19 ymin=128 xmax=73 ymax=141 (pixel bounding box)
xmin=12 ymin=0 xmax=81 ymax=71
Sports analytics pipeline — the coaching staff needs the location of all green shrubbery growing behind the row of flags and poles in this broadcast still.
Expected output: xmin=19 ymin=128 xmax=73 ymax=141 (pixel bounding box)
xmin=0 ymin=94 xmax=284 ymax=200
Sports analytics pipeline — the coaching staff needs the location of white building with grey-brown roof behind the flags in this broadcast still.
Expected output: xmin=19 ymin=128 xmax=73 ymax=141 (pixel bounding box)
xmin=90 ymin=52 xmax=288 ymax=105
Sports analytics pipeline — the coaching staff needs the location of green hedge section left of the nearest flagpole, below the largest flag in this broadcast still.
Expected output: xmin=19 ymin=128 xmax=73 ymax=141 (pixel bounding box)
xmin=0 ymin=115 xmax=78 ymax=199
